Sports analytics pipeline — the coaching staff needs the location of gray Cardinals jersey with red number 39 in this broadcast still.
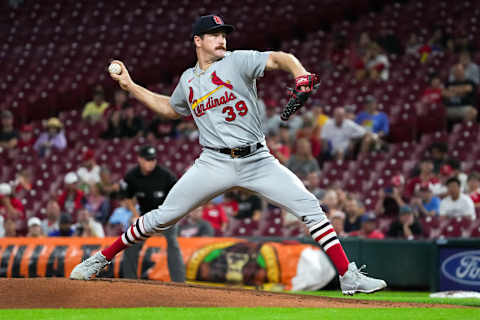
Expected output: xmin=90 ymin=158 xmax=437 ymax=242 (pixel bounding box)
xmin=170 ymin=50 xmax=269 ymax=148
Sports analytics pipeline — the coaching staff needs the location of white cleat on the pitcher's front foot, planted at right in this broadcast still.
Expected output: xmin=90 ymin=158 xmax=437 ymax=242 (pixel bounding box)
xmin=340 ymin=262 xmax=387 ymax=296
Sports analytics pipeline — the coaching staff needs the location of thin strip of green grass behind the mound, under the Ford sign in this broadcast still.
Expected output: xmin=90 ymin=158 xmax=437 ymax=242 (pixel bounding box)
xmin=298 ymin=291 xmax=480 ymax=308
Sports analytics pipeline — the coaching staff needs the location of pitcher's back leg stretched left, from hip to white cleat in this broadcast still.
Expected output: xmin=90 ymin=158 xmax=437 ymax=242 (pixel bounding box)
xmin=70 ymin=150 xmax=237 ymax=280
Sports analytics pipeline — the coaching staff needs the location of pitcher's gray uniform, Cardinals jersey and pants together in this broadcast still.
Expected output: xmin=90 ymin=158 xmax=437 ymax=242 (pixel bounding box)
xmin=122 ymin=51 xmax=326 ymax=250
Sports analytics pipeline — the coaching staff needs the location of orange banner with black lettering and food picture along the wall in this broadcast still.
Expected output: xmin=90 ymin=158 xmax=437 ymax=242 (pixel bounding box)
xmin=0 ymin=237 xmax=335 ymax=290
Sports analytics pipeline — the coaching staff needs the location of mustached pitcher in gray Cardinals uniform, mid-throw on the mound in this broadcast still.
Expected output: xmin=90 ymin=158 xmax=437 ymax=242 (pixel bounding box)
xmin=70 ymin=15 xmax=386 ymax=295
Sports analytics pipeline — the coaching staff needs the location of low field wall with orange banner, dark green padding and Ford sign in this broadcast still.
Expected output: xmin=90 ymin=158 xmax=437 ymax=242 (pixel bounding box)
xmin=0 ymin=237 xmax=480 ymax=291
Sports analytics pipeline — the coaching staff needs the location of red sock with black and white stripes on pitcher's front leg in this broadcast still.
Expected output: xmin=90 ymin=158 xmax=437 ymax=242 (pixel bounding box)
xmin=310 ymin=220 xmax=349 ymax=276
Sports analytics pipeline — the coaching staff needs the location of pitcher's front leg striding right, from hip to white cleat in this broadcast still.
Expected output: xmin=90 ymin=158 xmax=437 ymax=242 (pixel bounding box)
xmin=240 ymin=151 xmax=386 ymax=294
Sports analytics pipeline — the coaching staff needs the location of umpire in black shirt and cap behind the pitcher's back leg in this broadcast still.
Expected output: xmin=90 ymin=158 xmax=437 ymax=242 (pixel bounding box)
xmin=121 ymin=145 xmax=185 ymax=282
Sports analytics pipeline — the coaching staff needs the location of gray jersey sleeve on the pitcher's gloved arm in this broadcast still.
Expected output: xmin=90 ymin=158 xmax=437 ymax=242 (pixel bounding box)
xmin=232 ymin=50 xmax=270 ymax=79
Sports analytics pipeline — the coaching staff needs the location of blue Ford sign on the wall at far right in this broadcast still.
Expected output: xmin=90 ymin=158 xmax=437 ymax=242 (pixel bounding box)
xmin=439 ymin=247 xmax=480 ymax=291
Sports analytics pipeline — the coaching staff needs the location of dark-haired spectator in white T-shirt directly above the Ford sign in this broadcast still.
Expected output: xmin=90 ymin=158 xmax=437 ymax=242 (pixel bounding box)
xmin=440 ymin=177 xmax=475 ymax=220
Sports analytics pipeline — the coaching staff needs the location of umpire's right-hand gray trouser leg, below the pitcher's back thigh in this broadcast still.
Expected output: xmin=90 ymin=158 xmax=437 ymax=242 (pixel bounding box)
xmin=163 ymin=226 xmax=185 ymax=282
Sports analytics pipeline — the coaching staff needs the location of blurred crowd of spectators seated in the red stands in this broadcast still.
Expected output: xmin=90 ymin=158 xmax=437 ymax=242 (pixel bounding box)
xmin=0 ymin=1 xmax=480 ymax=239
